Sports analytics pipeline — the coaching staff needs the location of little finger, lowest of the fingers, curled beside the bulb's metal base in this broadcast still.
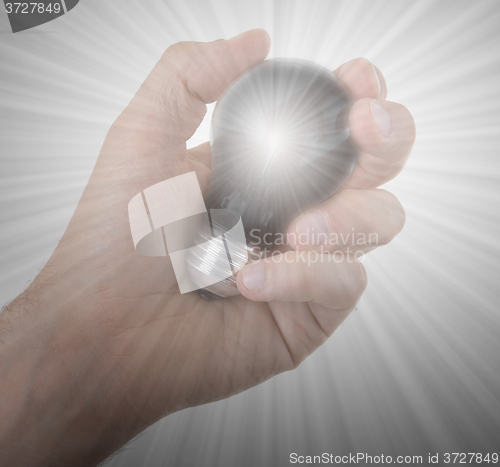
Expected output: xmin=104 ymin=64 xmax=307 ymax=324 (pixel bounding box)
xmin=237 ymin=251 xmax=366 ymax=310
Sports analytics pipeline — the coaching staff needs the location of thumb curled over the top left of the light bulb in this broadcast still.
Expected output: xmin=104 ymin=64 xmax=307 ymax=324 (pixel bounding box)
xmin=111 ymin=29 xmax=270 ymax=153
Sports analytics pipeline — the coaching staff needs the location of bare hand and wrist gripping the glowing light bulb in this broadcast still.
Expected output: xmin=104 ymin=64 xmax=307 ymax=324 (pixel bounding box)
xmin=0 ymin=30 xmax=415 ymax=466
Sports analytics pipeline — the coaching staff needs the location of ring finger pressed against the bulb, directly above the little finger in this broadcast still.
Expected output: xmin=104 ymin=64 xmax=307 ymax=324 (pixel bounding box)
xmin=287 ymin=189 xmax=405 ymax=253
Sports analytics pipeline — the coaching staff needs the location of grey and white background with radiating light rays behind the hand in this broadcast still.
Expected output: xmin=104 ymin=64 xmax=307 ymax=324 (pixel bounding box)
xmin=0 ymin=0 xmax=500 ymax=467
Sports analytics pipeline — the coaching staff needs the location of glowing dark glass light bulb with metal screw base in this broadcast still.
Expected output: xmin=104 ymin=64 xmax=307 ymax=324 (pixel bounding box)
xmin=188 ymin=59 xmax=358 ymax=298
